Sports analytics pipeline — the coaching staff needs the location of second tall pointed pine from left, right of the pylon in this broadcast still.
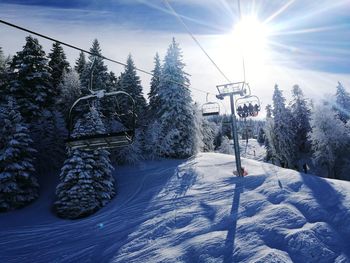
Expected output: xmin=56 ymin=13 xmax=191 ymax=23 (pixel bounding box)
xmin=290 ymin=85 xmax=311 ymax=155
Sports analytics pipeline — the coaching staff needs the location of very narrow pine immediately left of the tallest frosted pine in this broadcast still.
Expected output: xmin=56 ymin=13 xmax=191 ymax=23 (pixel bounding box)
xmin=148 ymin=53 xmax=161 ymax=119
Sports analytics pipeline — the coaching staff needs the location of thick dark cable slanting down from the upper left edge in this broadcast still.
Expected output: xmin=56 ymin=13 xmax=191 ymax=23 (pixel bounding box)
xmin=0 ymin=19 xmax=215 ymax=95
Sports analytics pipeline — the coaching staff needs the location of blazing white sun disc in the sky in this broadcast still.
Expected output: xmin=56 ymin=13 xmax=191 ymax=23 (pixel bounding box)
xmin=231 ymin=16 xmax=269 ymax=58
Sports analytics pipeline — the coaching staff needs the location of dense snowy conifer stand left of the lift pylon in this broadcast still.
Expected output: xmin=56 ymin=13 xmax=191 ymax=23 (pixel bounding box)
xmin=0 ymin=36 xmax=208 ymax=218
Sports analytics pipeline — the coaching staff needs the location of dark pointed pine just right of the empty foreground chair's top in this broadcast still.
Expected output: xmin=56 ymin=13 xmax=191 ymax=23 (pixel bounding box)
xmin=119 ymin=55 xmax=146 ymax=124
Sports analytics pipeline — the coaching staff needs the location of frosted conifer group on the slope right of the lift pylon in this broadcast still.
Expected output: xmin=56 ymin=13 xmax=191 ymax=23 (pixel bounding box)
xmin=262 ymin=83 xmax=350 ymax=180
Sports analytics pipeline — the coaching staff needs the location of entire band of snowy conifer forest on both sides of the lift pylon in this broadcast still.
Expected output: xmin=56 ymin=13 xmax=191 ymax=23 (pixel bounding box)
xmin=0 ymin=36 xmax=350 ymax=219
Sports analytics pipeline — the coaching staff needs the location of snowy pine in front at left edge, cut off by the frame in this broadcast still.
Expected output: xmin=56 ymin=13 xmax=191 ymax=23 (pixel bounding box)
xmin=0 ymin=98 xmax=39 ymax=211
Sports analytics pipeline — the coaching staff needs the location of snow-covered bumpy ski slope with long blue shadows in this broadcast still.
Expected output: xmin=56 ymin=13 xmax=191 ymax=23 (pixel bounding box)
xmin=0 ymin=153 xmax=350 ymax=263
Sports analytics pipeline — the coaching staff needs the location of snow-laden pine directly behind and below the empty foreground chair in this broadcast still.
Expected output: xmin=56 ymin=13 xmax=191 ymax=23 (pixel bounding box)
xmin=54 ymin=107 xmax=115 ymax=219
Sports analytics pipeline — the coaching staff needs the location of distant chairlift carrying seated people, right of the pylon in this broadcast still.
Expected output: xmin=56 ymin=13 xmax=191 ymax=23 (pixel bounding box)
xmin=236 ymin=95 xmax=261 ymax=118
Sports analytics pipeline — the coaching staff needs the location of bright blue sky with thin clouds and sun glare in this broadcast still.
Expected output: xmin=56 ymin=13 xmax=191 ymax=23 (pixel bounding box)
xmin=0 ymin=0 xmax=350 ymax=115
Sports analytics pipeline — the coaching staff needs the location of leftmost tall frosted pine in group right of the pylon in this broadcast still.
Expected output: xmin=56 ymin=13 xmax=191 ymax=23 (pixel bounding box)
xmin=271 ymin=85 xmax=298 ymax=168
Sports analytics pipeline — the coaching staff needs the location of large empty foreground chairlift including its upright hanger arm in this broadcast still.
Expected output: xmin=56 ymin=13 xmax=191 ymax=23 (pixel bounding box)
xmin=66 ymin=59 xmax=136 ymax=151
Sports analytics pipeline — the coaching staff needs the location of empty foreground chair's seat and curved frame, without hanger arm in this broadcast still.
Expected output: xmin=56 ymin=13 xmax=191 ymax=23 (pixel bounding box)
xmin=66 ymin=90 xmax=136 ymax=150
